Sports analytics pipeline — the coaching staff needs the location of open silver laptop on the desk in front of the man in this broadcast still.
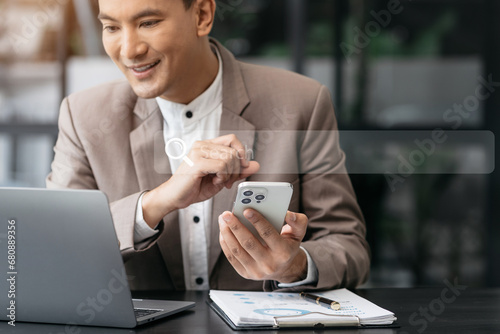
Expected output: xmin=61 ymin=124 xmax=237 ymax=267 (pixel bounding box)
xmin=0 ymin=188 xmax=195 ymax=328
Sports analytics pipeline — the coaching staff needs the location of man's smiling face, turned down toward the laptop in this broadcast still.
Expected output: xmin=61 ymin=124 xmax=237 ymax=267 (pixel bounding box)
xmin=99 ymin=0 xmax=200 ymax=101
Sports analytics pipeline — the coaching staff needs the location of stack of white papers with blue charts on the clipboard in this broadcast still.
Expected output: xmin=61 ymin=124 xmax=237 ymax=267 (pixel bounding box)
xmin=210 ymin=289 xmax=396 ymax=327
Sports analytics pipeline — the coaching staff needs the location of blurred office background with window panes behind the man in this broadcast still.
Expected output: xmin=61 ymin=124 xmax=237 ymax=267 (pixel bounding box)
xmin=0 ymin=0 xmax=500 ymax=287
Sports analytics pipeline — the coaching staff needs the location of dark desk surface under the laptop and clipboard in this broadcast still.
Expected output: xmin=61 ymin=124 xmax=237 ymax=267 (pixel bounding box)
xmin=0 ymin=286 xmax=500 ymax=334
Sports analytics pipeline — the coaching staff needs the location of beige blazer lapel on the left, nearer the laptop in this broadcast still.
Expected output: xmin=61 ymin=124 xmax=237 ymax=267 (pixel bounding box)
xmin=130 ymin=98 xmax=185 ymax=290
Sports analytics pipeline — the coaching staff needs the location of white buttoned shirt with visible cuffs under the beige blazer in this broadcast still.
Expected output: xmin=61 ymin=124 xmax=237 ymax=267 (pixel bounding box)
xmin=134 ymin=49 xmax=317 ymax=290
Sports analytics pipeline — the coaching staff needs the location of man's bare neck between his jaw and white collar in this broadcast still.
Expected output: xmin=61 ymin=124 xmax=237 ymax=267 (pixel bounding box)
xmin=160 ymin=38 xmax=219 ymax=104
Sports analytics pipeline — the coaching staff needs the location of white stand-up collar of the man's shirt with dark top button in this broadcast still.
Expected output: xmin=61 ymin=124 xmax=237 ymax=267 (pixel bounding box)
xmin=156 ymin=47 xmax=222 ymax=128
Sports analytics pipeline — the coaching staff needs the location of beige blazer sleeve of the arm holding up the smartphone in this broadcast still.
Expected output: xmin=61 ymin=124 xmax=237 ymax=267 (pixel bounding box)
xmin=264 ymin=86 xmax=370 ymax=291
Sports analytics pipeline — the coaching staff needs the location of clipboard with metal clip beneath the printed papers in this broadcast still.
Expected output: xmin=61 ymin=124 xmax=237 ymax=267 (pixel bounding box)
xmin=207 ymin=298 xmax=400 ymax=331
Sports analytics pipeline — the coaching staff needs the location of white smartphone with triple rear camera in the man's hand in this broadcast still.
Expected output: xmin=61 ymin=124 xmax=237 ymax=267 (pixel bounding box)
xmin=233 ymin=182 xmax=293 ymax=240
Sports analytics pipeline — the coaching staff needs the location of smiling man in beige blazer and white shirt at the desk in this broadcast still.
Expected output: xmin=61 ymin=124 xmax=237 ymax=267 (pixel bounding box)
xmin=47 ymin=0 xmax=369 ymax=290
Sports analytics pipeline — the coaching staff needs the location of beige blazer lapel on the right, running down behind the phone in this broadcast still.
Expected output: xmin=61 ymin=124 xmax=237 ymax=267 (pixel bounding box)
xmin=208 ymin=39 xmax=255 ymax=274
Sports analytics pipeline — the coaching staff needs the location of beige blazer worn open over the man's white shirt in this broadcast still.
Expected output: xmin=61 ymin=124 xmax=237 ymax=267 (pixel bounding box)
xmin=47 ymin=40 xmax=370 ymax=290
